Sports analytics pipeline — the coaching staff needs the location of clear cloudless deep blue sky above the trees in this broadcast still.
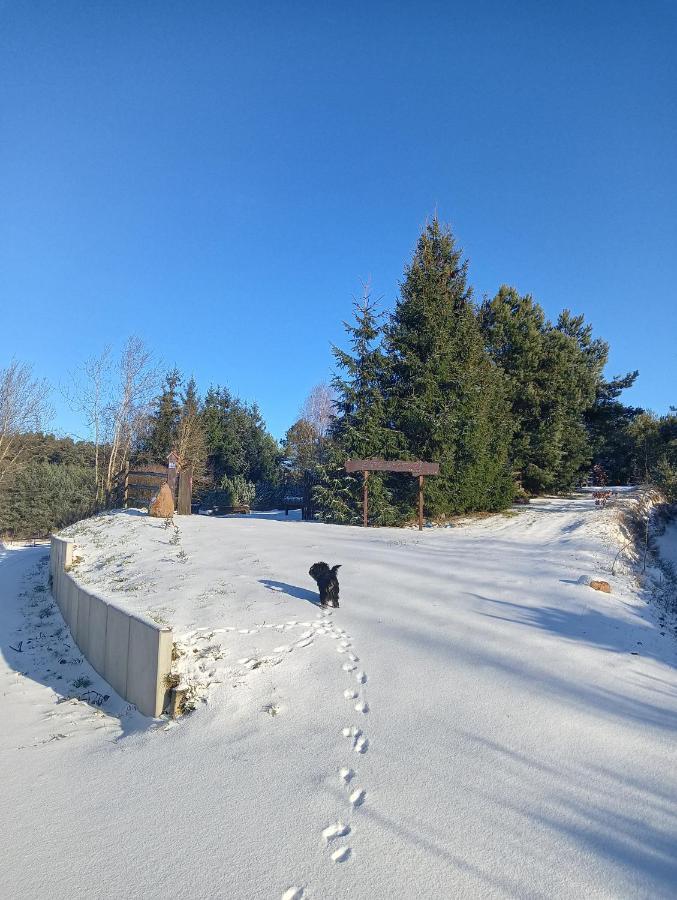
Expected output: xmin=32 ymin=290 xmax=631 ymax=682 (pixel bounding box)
xmin=0 ymin=0 xmax=677 ymax=436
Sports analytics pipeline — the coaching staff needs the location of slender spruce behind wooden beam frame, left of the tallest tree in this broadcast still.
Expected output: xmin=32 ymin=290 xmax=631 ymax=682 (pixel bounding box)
xmin=315 ymin=288 xmax=403 ymax=525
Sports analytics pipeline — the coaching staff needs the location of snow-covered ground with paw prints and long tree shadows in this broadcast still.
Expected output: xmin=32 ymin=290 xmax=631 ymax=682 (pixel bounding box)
xmin=0 ymin=497 xmax=677 ymax=900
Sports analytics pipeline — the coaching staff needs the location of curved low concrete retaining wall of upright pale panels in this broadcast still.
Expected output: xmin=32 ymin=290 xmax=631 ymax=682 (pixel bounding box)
xmin=49 ymin=536 xmax=173 ymax=716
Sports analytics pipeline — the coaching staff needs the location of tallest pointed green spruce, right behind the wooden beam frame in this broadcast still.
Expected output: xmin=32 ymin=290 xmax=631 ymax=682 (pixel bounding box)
xmin=387 ymin=218 xmax=514 ymax=515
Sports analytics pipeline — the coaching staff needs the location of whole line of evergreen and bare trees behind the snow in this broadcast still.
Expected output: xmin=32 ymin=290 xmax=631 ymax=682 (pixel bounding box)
xmin=0 ymin=219 xmax=677 ymax=538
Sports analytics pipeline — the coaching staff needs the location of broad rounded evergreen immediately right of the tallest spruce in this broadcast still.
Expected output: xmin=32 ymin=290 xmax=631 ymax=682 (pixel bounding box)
xmin=480 ymin=285 xmax=636 ymax=494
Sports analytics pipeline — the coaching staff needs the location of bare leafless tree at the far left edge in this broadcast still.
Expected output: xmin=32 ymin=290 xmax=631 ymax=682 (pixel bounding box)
xmin=0 ymin=360 xmax=50 ymax=484
